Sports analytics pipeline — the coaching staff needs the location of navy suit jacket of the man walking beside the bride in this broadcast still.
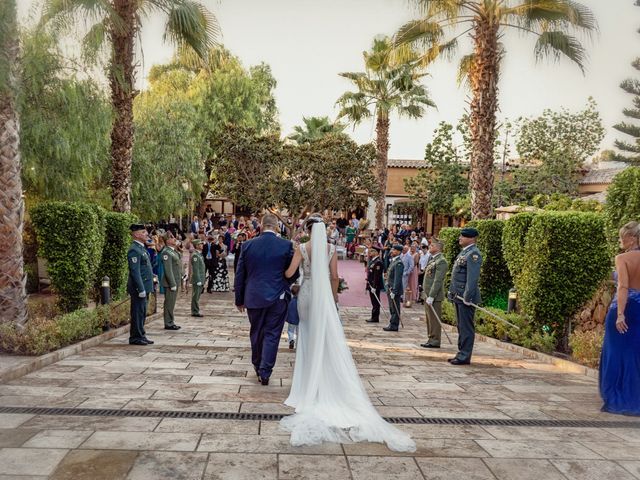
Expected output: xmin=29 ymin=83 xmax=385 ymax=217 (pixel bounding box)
xmin=234 ymin=232 xmax=295 ymax=308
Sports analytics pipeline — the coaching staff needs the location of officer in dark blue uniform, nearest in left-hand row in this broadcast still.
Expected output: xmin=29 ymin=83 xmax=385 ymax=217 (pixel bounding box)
xmin=127 ymin=223 xmax=153 ymax=345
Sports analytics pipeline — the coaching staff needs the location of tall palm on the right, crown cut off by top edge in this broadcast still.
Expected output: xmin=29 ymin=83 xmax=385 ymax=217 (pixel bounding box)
xmin=395 ymin=0 xmax=597 ymax=218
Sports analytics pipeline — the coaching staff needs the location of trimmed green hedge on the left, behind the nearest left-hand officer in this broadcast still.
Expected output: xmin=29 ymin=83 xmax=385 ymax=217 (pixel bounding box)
xmin=30 ymin=202 xmax=134 ymax=312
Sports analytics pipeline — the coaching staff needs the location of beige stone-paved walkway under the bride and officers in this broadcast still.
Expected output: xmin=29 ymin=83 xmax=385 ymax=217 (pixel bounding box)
xmin=0 ymin=294 xmax=640 ymax=480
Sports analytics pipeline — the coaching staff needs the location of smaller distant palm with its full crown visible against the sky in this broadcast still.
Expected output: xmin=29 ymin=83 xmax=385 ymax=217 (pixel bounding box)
xmin=336 ymin=37 xmax=435 ymax=227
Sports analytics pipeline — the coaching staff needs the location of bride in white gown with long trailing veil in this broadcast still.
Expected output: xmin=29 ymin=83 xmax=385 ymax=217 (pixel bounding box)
xmin=280 ymin=214 xmax=416 ymax=452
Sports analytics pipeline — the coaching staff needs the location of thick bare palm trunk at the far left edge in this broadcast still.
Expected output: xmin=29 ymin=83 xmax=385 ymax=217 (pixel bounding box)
xmin=0 ymin=0 xmax=27 ymax=325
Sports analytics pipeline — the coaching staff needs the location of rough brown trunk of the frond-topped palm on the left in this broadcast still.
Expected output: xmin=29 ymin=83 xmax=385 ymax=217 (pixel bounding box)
xmin=109 ymin=0 xmax=139 ymax=212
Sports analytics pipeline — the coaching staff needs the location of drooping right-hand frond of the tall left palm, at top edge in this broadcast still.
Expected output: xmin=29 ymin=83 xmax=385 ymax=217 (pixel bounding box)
xmin=164 ymin=0 xmax=220 ymax=59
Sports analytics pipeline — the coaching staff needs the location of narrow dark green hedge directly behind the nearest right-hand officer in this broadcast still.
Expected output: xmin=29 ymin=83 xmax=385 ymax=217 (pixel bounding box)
xmin=469 ymin=220 xmax=513 ymax=310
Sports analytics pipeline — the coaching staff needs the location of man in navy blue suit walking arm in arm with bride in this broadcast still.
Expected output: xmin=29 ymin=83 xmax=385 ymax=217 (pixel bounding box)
xmin=234 ymin=214 xmax=295 ymax=385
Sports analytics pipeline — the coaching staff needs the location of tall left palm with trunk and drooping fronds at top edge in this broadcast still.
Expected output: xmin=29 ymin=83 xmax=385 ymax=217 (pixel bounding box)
xmin=42 ymin=0 xmax=219 ymax=212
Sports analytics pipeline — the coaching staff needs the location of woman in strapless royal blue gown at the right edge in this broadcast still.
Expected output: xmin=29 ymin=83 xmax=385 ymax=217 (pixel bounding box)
xmin=600 ymin=222 xmax=640 ymax=416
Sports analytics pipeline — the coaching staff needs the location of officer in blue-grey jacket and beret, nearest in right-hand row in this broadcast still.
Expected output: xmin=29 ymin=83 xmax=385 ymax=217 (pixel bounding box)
xmin=448 ymin=228 xmax=482 ymax=365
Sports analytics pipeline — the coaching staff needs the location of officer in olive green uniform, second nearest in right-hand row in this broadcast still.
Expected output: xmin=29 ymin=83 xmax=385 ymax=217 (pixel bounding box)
xmin=420 ymin=239 xmax=449 ymax=348
